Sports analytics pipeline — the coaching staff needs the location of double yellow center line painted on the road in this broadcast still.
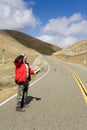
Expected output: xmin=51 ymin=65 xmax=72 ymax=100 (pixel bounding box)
xmin=64 ymin=66 xmax=87 ymax=103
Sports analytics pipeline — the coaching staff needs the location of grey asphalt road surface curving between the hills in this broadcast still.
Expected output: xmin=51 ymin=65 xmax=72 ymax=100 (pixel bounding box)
xmin=0 ymin=57 xmax=87 ymax=130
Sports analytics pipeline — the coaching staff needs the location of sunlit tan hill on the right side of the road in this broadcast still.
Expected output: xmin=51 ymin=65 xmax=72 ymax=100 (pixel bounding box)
xmin=53 ymin=39 xmax=87 ymax=67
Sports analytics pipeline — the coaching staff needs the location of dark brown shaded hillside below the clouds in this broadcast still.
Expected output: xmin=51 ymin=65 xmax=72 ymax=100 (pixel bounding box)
xmin=0 ymin=30 xmax=60 ymax=55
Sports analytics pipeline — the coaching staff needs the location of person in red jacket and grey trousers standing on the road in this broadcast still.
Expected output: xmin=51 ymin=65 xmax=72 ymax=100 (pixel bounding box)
xmin=14 ymin=54 xmax=40 ymax=112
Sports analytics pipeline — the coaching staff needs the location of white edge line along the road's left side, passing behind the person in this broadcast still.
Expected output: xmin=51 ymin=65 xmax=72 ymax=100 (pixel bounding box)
xmin=0 ymin=62 xmax=50 ymax=106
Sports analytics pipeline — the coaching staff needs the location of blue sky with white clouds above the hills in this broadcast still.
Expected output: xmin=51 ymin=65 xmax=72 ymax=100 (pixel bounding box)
xmin=0 ymin=0 xmax=87 ymax=48
